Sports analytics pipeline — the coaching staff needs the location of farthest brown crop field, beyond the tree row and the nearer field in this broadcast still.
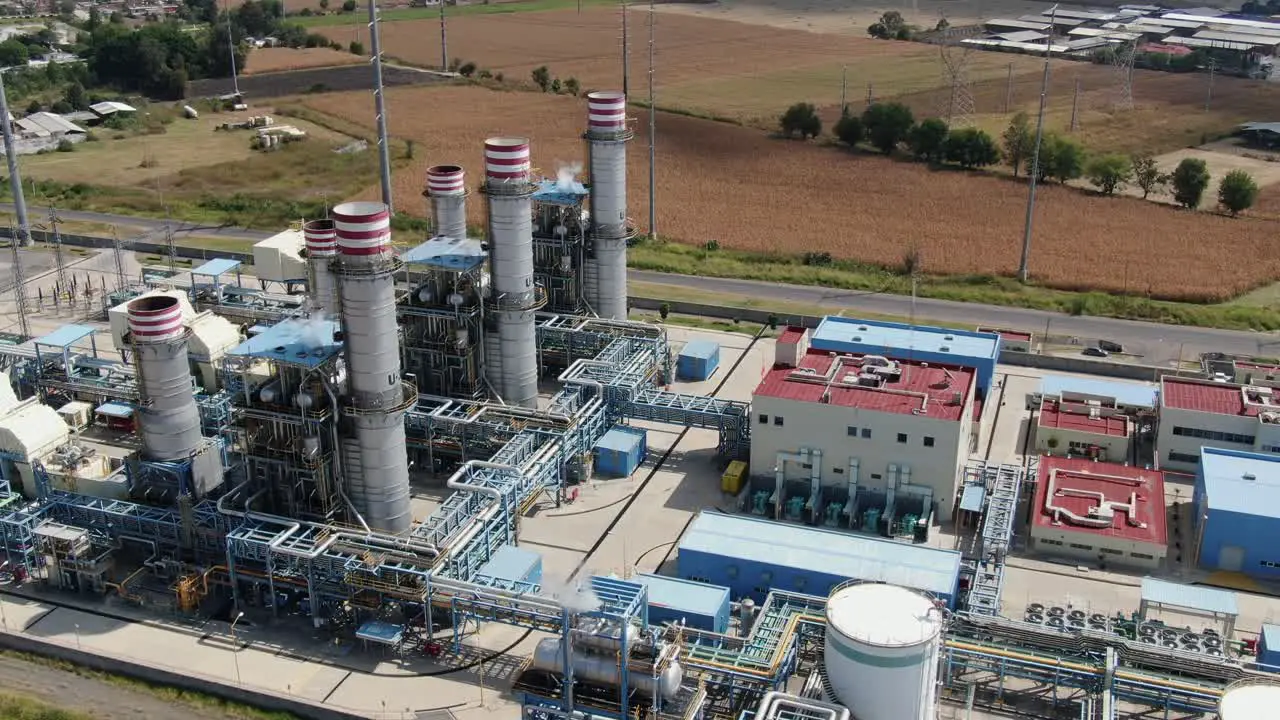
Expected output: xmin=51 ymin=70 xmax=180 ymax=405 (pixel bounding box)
xmin=320 ymin=9 xmax=1038 ymax=123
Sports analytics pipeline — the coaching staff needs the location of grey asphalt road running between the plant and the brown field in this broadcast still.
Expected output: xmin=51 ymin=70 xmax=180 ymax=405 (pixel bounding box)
xmin=0 ymin=204 xmax=1280 ymax=365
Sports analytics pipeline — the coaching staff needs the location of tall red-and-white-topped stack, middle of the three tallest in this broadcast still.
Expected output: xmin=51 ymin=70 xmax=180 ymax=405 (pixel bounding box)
xmin=484 ymin=137 xmax=547 ymax=407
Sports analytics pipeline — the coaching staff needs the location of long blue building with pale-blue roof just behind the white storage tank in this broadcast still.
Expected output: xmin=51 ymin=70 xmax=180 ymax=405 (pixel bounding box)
xmin=676 ymin=512 xmax=960 ymax=606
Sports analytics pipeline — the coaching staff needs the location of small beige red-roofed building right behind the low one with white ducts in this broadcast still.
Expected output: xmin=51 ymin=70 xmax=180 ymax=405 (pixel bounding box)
xmin=1036 ymin=397 xmax=1132 ymax=462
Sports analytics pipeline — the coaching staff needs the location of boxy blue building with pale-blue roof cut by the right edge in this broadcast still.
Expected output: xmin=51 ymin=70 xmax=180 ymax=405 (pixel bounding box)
xmin=1192 ymin=447 xmax=1280 ymax=579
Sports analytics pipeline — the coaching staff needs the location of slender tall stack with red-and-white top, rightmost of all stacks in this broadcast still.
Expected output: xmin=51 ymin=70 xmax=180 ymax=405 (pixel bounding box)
xmin=586 ymin=92 xmax=634 ymax=320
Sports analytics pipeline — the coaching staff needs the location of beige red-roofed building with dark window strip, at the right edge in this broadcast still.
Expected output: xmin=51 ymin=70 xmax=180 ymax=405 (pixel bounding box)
xmin=1156 ymin=377 xmax=1280 ymax=474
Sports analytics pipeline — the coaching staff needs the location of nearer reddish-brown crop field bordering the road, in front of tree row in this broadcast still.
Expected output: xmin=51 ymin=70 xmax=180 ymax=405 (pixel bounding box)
xmin=303 ymin=86 xmax=1280 ymax=300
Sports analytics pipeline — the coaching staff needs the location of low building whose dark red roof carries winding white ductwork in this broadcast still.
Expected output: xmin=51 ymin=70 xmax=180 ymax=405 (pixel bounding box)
xmin=1030 ymin=456 xmax=1169 ymax=570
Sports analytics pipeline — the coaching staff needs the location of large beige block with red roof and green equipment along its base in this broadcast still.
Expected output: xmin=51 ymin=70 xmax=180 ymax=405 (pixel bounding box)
xmin=751 ymin=328 xmax=978 ymax=527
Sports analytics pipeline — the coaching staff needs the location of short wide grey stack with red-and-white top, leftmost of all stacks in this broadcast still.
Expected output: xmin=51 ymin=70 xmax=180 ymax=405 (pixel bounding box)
xmin=128 ymin=295 xmax=204 ymax=460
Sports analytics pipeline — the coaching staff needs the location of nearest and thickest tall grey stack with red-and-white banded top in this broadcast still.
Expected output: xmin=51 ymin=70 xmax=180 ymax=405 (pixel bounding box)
xmin=333 ymin=202 xmax=417 ymax=533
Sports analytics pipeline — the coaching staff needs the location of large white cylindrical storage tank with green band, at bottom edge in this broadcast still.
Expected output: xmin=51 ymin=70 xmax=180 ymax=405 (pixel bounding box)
xmin=824 ymin=583 xmax=942 ymax=720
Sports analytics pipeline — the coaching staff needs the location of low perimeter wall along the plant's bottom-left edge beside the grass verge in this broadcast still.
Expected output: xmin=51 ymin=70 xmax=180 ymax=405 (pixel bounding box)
xmin=0 ymin=630 xmax=365 ymax=720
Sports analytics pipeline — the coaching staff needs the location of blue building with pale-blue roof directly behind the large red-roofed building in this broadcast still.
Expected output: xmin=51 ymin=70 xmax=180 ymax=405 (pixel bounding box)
xmin=809 ymin=316 xmax=1000 ymax=397
